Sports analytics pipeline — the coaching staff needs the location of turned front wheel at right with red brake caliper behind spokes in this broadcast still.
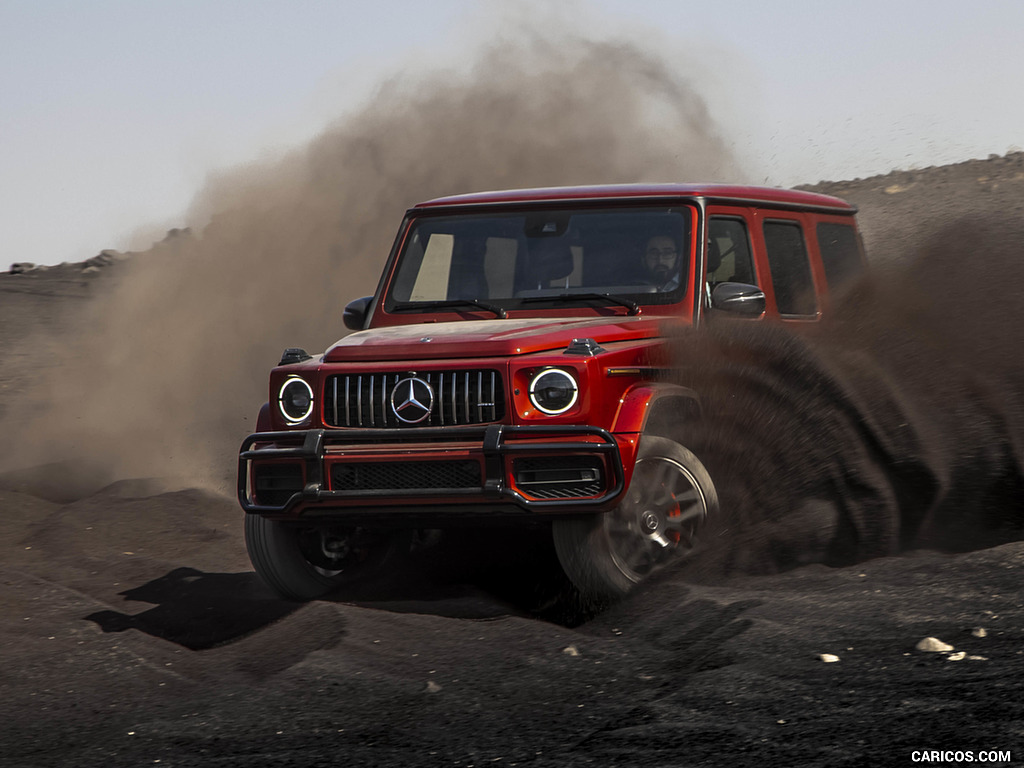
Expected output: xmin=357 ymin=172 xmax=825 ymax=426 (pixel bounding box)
xmin=553 ymin=435 xmax=718 ymax=603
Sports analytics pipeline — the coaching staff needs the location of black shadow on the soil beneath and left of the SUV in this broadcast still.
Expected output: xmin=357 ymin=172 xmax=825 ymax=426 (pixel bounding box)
xmin=85 ymin=535 xmax=594 ymax=651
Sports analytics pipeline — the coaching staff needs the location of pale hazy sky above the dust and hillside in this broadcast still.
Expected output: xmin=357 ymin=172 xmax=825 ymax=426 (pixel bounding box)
xmin=0 ymin=0 xmax=1024 ymax=270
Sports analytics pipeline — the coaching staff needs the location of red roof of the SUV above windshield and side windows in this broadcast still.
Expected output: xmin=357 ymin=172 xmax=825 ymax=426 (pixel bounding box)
xmin=414 ymin=183 xmax=857 ymax=213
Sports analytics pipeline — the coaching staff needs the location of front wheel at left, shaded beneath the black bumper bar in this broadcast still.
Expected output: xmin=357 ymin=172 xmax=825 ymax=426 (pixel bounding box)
xmin=246 ymin=514 xmax=402 ymax=601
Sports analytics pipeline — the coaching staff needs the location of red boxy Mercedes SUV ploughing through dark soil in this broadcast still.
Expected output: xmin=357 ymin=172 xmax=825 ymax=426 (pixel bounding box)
xmin=239 ymin=184 xmax=864 ymax=601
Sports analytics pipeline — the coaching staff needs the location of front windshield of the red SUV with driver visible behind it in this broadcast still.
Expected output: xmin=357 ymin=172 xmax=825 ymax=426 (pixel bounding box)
xmin=385 ymin=206 xmax=695 ymax=311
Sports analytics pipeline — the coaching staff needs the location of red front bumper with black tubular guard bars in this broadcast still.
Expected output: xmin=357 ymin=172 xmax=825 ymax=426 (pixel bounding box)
xmin=238 ymin=424 xmax=636 ymax=519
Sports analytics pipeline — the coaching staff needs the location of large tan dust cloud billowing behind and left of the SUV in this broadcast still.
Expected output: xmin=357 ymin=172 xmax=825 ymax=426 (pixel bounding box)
xmin=0 ymin=28 xmax=743 ymax=489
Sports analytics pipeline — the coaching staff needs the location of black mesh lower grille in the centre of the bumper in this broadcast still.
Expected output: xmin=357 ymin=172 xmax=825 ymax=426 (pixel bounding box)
xmin=331 ymin=461 xmax=481 ymax=490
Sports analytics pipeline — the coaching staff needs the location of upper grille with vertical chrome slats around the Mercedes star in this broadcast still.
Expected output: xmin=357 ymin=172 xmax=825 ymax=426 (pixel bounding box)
xmin=324 ymin=369 xmax=505 ymax=428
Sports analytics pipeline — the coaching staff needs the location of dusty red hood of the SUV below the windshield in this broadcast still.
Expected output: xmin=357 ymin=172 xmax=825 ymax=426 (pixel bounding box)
xmin=324 ymin=315 xmax=666 ymax=362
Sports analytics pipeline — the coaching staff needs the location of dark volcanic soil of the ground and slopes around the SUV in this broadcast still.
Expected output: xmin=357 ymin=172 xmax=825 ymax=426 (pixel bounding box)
xmin=0 ymin=155 xmax=1024 ymax=768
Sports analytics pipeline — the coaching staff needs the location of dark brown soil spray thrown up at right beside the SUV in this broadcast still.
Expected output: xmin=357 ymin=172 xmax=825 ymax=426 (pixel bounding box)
xmin=675 ymin=217 xmax=1024 ymax=572
